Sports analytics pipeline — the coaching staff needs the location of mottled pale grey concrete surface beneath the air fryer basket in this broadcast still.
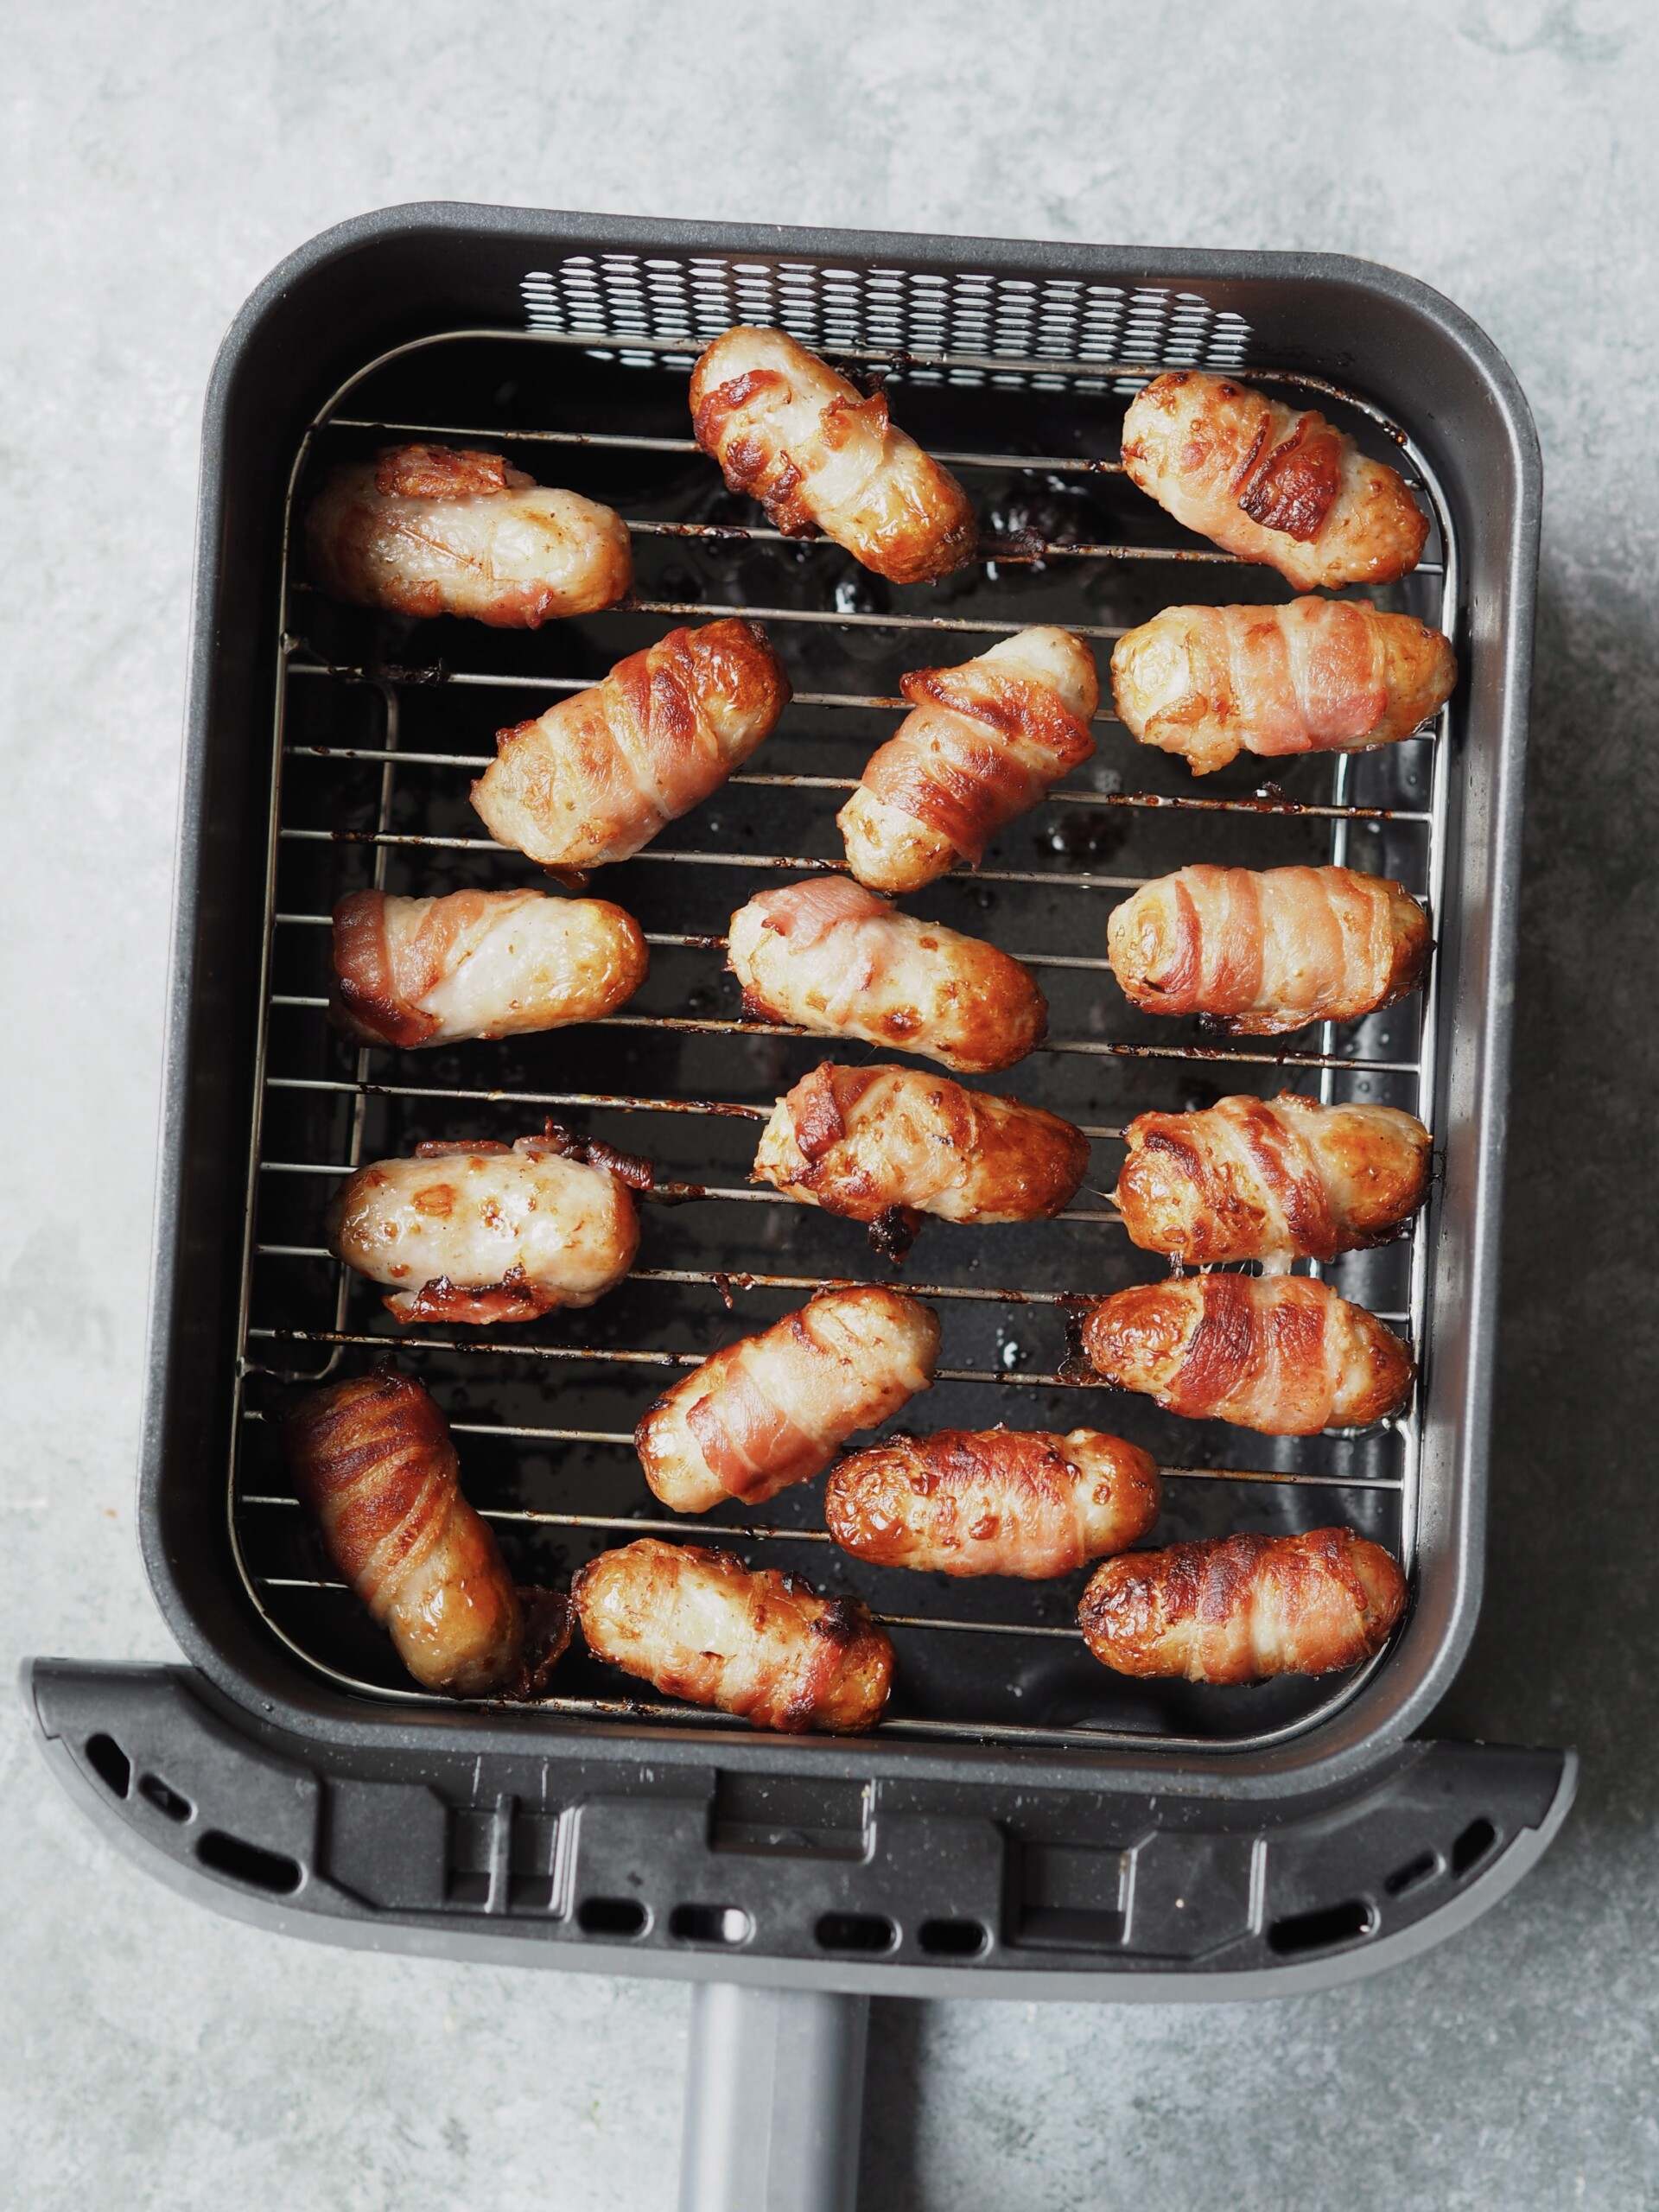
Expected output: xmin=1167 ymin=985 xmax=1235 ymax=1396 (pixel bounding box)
xmin=0 ymin=0 xmax=1659 ymax=2212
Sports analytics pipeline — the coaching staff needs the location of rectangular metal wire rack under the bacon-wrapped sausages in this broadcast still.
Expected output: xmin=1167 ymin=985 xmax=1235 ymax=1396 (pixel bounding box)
xmin=228 ymin=270 xmax=1458 ymax=1752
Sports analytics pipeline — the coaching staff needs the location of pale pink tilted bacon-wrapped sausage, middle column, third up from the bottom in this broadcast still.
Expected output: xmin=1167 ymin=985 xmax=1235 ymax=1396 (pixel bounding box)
xmin=632 ymin=1283 xmax=938 ymax=1513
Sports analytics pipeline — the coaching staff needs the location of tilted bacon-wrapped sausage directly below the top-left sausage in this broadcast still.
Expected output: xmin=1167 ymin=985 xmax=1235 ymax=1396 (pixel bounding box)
xmin=474 ymin=621 xmax=790 ymax=876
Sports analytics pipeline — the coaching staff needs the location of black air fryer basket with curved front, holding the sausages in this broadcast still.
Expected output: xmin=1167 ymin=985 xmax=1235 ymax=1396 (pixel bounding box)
xmin=27 ymin=206 xmax=1573 ymax=2203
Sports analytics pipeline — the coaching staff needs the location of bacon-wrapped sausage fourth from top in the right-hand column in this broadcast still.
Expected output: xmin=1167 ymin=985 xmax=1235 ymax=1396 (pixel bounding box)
xmin=1115 ymin=1090 xmax=1433 ymax=1268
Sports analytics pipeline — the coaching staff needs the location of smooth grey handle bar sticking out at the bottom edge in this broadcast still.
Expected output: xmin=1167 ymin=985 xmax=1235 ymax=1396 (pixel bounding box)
xmin=679 ymin=1982 xmax=869 ymax=2212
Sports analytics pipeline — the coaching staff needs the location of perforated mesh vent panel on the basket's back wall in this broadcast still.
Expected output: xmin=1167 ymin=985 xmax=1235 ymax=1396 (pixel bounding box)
xmin=522 ymin=254 xmax=1249 ymax=391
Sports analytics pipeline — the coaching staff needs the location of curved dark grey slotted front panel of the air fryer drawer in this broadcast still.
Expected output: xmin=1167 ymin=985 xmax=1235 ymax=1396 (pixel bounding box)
xmin=22 ymin=1659 xmax=1577 ymax=2008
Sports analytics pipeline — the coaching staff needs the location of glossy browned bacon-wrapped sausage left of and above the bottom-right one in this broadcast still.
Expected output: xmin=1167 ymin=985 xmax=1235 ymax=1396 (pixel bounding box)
xmin=823 ymin=1429 xmax=1159 ymax=1580
